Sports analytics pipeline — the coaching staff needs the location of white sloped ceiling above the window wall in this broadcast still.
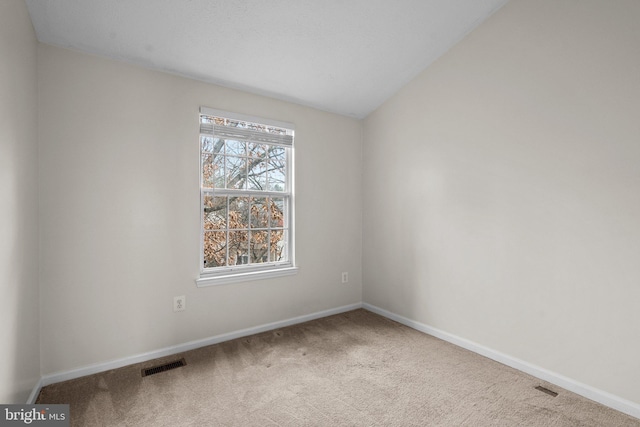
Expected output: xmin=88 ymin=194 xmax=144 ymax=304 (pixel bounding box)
xmin=26 ymin=0 xmax=508 ymax=118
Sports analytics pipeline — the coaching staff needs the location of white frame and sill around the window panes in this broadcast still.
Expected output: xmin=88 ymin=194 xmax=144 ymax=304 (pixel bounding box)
xmin=196 ymin=107 xmax=298 ymax=287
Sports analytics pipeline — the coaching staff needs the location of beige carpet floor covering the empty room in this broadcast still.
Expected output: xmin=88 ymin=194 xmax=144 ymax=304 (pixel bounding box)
xmin=38 ymin=310 xmax=640 ymax=427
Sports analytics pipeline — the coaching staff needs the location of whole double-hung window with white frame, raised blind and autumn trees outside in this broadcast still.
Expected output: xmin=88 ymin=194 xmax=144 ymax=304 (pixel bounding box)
xmin=197 ymin=107 xmax=295 ymax=286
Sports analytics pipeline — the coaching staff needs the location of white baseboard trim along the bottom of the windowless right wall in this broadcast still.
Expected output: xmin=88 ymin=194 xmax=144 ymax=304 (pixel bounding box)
xmin=362 ymin=303 xmax=640 ymax=418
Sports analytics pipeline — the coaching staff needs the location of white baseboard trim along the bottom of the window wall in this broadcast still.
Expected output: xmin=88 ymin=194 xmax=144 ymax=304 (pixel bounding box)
xmin=40 ymin=303 xmax=362 ymax=390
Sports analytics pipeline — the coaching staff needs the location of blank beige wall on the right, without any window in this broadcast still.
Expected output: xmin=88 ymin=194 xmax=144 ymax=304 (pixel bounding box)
xmin=363 ymin=0 xmax=640 ymax=403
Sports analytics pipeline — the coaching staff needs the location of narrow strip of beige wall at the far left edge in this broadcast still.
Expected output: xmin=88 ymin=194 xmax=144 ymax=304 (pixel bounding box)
xmin=0 ymin=0 xmax=40 ymax=403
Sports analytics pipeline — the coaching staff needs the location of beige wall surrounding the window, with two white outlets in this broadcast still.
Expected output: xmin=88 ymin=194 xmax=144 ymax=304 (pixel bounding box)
xmin=38 ymin=45 xmax=362 ymax=374
